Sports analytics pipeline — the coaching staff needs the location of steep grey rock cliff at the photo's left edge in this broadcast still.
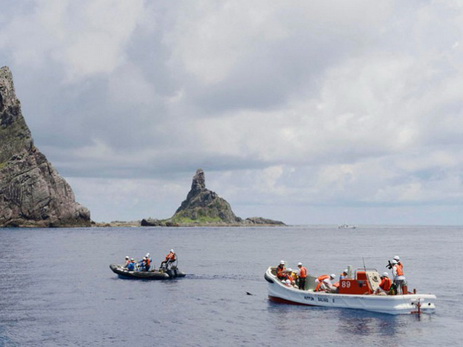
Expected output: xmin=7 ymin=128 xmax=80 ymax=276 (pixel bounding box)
xmin=0 ymin=67 xmax=91 ymax=227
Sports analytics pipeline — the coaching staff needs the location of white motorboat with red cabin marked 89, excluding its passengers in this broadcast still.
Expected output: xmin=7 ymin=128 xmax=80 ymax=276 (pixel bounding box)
xmin=265 ymin=267 xmax=436 ymax=315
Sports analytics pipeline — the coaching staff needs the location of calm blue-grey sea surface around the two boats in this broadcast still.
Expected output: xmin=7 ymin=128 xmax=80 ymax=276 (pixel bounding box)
xmin=0 ymin=226 xmax=463 ymax=347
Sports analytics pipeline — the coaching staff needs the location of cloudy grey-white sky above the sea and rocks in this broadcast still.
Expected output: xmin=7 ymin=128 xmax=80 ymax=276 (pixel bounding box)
xmin=0 ymin=0 xmax=463 ymax=225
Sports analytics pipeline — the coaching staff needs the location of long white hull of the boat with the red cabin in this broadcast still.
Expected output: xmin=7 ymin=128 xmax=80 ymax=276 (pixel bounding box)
xmin=265 ymin=268 xmax=436 ymax=315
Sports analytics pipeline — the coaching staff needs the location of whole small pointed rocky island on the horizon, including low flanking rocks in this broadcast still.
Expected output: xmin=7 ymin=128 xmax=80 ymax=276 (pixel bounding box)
xmin=141 ymin=169 xmax=285 ymax=226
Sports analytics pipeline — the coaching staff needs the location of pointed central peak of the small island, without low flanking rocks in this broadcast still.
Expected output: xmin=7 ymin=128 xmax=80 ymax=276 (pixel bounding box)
xmin=171 ymin=169 xmax=242 ymax=224
